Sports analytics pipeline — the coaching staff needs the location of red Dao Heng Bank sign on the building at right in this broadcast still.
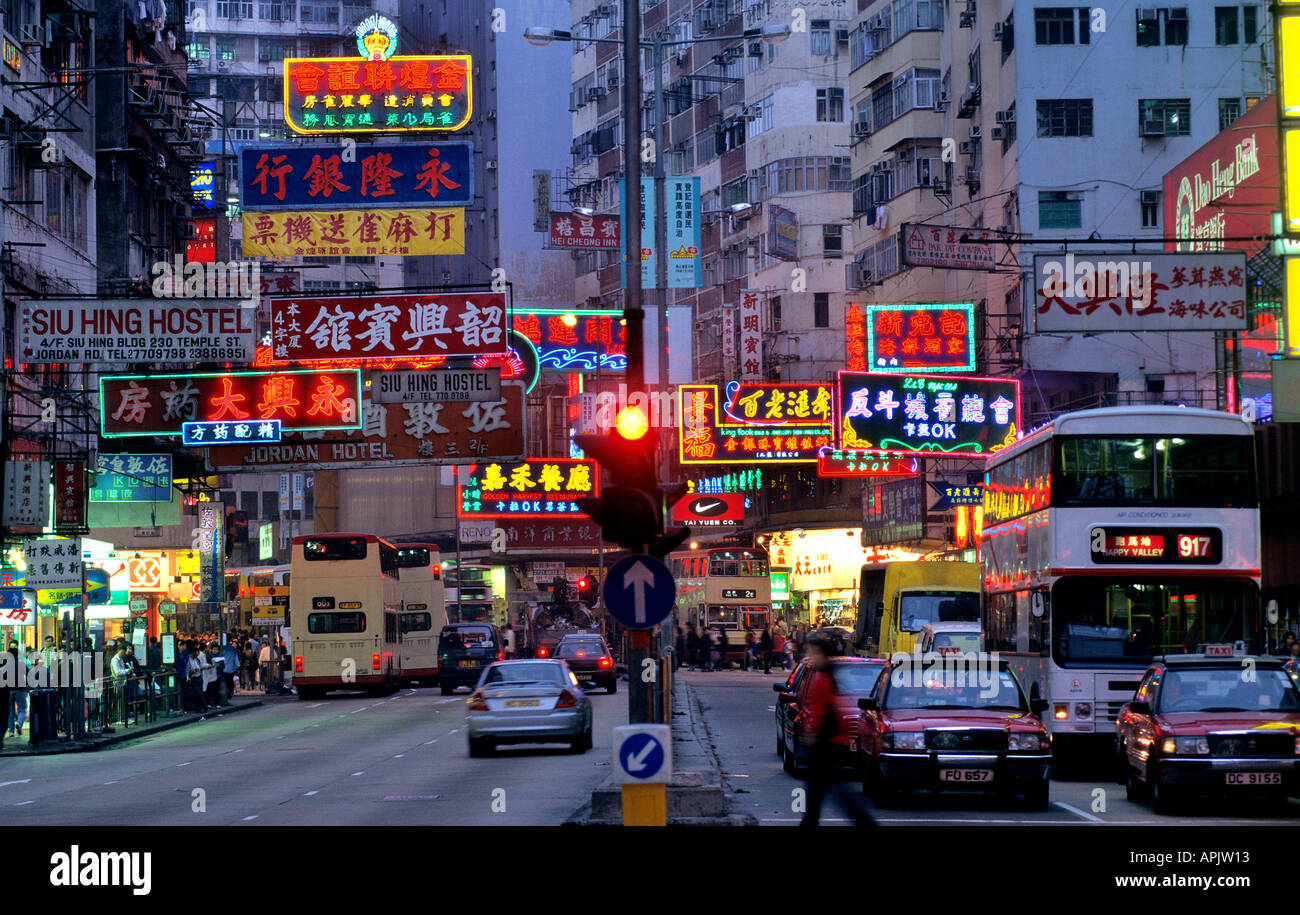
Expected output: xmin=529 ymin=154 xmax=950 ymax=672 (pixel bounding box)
xmin=1162 ymin=96 xmax=1279 ymax=251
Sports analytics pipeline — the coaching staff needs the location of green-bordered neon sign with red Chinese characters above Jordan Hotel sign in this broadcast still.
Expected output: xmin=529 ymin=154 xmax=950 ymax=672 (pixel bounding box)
xmin=99 ymin=368 xmax=361 ymax=438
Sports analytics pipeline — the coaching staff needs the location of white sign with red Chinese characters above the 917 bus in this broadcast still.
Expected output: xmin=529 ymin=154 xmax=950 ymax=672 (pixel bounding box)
xmin=1034 ymin=251 xmax=1247 ymax=333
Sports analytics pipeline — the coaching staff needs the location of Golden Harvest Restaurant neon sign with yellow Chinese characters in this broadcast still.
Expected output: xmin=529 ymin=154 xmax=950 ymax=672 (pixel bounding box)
xmin=456 ymin=458 xmax=601 ymax=519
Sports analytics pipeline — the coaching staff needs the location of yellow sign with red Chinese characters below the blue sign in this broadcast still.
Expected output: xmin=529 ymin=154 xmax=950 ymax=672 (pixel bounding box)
xmin=241 ymin=204 xmax=465 ymax=257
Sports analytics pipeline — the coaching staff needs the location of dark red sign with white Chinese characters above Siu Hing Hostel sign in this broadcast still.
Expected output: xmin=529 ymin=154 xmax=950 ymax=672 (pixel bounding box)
xmin=270 ymin=292 xmax=507 ymax=363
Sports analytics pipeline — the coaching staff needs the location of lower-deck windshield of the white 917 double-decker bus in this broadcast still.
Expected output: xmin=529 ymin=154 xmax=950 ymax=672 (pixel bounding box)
xmin=1052 ymin=578 xmax=1258 ymax=667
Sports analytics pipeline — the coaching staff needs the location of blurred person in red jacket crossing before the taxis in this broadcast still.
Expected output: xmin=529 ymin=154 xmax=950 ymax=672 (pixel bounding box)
xmin=800 ymin=638 xmax=876 ymax=827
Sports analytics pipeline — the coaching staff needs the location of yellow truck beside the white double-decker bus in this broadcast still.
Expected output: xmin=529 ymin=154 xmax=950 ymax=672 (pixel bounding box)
xmin=853 ymin=561 xmax=980 ymax=658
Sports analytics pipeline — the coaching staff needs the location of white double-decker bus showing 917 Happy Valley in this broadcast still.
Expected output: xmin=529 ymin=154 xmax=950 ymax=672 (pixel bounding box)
xmin=979 ymin=407 xmax=1264 ymax=754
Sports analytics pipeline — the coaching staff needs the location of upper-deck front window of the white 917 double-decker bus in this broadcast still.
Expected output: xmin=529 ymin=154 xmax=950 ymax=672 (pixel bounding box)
xmin=1052 ymin=435 xmax=1257 ymax=508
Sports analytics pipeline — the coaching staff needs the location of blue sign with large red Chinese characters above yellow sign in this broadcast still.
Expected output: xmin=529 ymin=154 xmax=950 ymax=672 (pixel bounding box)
xmin=239 ymin=140 xmax=475 ymax=212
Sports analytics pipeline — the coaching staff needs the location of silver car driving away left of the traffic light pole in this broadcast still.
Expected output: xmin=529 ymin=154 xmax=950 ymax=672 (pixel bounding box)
xmin=465 ymin=659 xmax=592 ymax=756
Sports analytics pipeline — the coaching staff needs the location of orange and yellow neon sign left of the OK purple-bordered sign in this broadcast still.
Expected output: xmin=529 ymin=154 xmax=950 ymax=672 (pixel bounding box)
xmin=679 ymin=381 xmax=832 ymax=464
